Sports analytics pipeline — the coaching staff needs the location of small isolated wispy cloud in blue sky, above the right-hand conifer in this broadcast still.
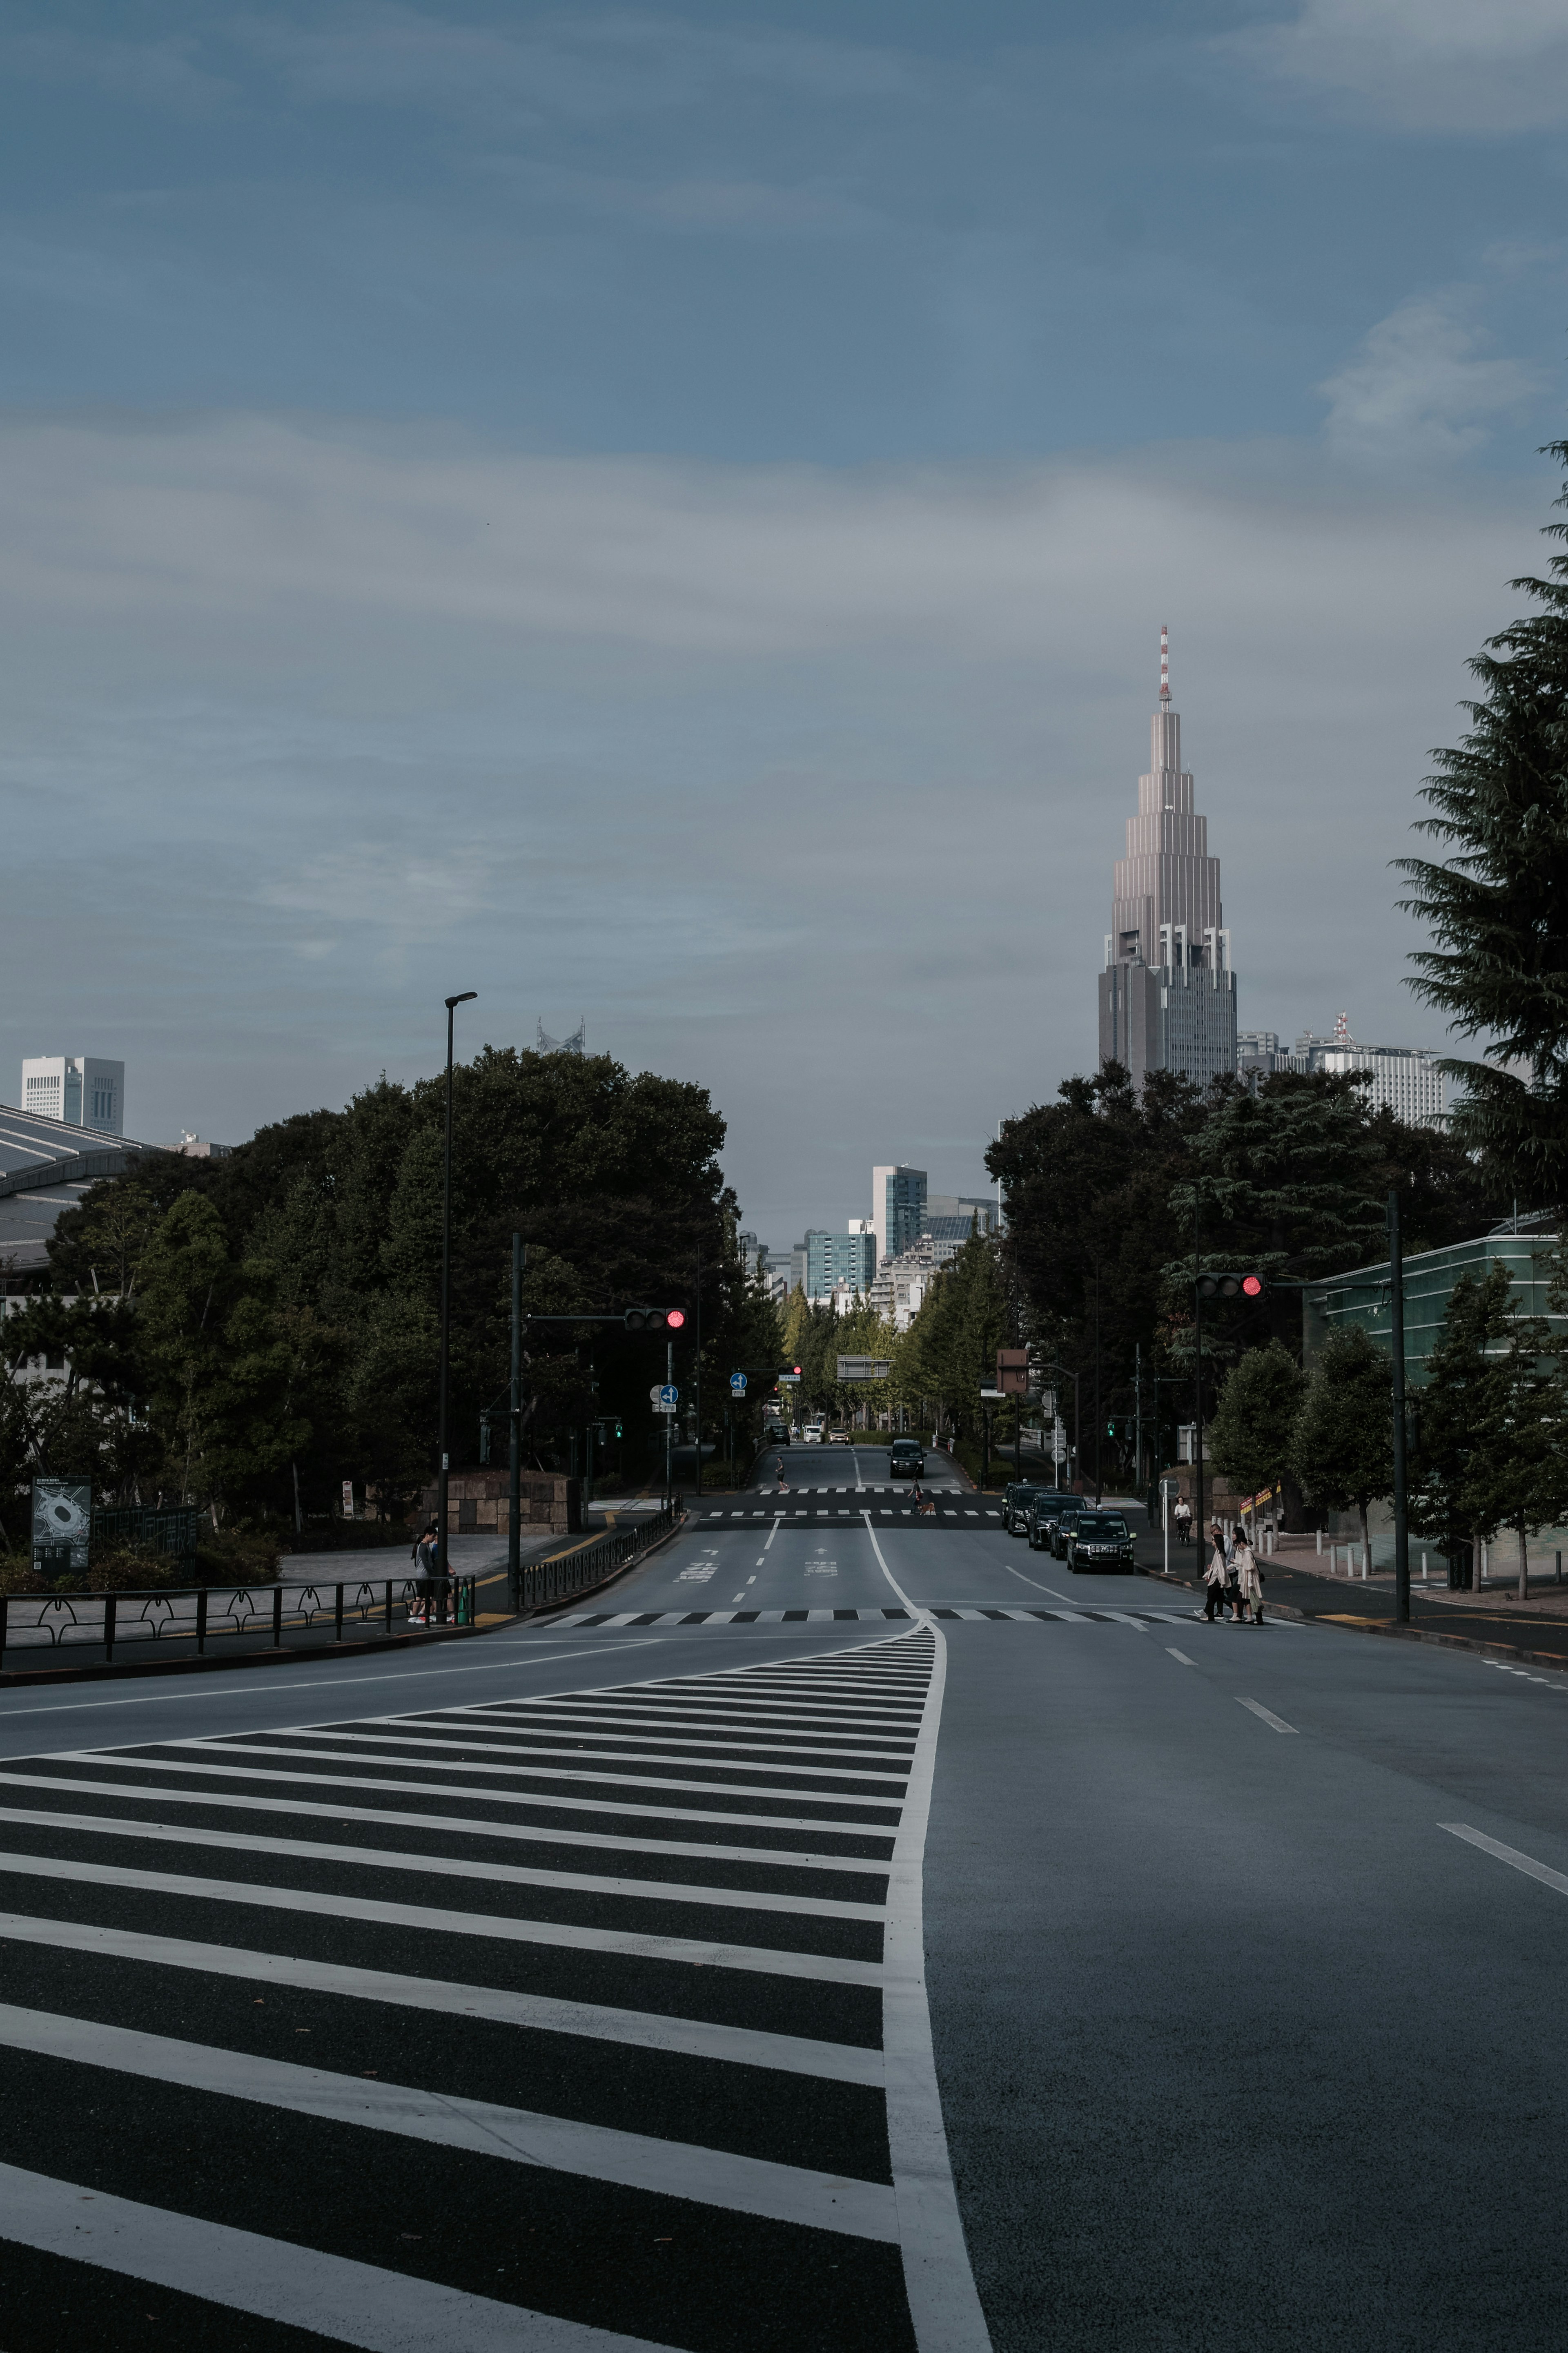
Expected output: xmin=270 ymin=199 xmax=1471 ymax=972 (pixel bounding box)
xmin=1319 ymin=294 xmax=1537 ymax=466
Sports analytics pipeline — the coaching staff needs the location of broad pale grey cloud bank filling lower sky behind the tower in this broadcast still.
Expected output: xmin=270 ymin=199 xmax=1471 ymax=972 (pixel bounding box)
xmin=0 ymin=414 xmax=1554 ymax=1240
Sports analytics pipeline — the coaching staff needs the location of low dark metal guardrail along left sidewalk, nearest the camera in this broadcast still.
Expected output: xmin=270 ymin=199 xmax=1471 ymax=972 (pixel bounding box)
xmin=0 ymin=1577 xmax=475 ymax=1666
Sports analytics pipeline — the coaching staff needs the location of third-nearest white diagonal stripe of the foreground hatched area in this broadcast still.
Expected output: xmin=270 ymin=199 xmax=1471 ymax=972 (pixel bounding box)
xmin=0 ymin=1913 xmax=882 ymax=2085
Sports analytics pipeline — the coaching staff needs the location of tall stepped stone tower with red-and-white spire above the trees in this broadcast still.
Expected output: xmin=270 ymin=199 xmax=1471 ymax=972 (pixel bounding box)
xmin=1100 ymin=624 xmax=1236 ymax=1085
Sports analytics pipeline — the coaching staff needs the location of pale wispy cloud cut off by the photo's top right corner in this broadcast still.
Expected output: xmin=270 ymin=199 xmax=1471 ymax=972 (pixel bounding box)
xmin=1218 ymin=0 xmax=1568 ymax=132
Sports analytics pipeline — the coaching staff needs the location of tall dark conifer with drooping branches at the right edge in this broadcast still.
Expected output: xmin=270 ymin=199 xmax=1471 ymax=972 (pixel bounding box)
xmin=1399 ymin=442 xmax=1568 ymax=1207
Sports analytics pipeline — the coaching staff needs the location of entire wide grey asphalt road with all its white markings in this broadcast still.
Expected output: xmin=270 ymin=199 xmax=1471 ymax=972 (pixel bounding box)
xmin=0 ymin=1477 xmax=1568 ymax=2353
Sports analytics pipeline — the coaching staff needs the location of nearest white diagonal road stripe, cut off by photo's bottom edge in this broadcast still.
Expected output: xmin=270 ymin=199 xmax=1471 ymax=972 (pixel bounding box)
xmin=0 ymin=2165 xmax=670 ymax=2353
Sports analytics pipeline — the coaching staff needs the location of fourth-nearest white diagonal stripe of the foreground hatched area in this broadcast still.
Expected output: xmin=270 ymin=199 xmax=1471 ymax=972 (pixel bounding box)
xmin=0 ymin=1854 xmax=882 ymax=1986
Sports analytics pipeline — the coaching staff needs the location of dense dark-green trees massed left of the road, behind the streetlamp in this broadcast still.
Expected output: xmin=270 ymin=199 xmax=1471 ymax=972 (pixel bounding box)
xmin=0 ymin=1047 xmax=778 ymax=1522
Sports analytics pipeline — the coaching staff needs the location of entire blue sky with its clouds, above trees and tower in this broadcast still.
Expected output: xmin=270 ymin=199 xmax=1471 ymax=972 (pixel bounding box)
xmin=0 ymin=0 xmax=1568 ymax=1242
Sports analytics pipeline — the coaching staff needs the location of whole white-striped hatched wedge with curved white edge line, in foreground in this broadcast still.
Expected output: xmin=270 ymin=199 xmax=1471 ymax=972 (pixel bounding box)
xmin=0 ymin=1624 xmax=987 ymax=2353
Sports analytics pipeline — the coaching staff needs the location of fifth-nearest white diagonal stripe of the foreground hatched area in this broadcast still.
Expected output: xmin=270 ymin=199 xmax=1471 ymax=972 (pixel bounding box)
xmin=0 ymin=1805 xmax=882 ymax=1920
